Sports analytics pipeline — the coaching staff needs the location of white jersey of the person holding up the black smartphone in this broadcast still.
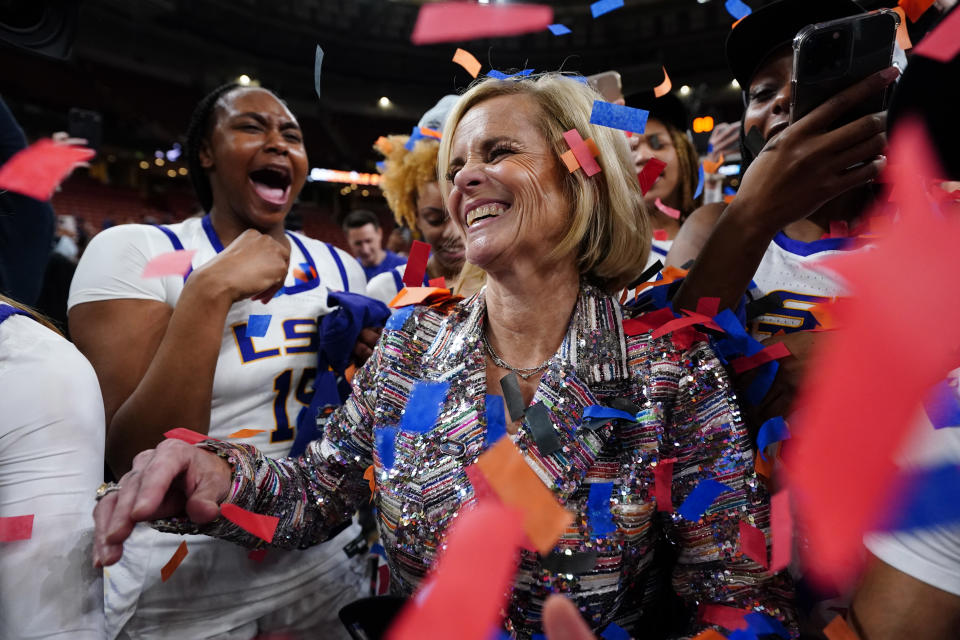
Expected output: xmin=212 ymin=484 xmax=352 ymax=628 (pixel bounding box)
xmin=747 ymin=231 xmax=851 ymax=340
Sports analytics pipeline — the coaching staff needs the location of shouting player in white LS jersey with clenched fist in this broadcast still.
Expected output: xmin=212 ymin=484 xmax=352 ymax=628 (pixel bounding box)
xmin=68 ymin=85 xmax=365 ymax=639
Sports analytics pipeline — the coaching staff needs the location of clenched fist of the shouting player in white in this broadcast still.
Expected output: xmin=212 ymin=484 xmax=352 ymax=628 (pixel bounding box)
xmin=187 ymin=229 xmax=290 ymax=303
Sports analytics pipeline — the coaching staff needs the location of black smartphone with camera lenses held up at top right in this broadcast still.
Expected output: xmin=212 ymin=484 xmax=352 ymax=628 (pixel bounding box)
xmin=790 ymin=9 xmax=900 ymax=126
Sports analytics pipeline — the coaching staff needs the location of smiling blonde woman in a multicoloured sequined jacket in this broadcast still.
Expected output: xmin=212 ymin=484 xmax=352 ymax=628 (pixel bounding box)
xmin=95 ymin=74 xmax=793 ymax=638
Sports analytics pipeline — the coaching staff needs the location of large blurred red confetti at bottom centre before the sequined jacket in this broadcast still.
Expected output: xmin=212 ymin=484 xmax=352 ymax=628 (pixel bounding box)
xmin=387 ymin=502 xmax=524 ymax=640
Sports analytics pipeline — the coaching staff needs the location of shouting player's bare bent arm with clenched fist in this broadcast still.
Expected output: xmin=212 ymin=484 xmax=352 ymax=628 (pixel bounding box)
xmin=69 ymin=230 xmax=289 ymax=476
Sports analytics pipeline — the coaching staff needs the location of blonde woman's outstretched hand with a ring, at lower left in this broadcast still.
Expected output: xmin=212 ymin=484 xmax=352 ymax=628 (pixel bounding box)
xmin=93 ymin=440 xmax=232 ymax=567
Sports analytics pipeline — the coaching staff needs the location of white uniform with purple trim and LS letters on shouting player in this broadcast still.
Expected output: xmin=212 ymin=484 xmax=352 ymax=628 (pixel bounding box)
xmin=68 ymin=217 xmax=366 ymax=638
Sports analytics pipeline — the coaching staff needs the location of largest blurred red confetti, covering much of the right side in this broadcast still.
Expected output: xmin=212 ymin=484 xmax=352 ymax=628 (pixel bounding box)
xmin=785 ymin=119 xmax=960 ymax=587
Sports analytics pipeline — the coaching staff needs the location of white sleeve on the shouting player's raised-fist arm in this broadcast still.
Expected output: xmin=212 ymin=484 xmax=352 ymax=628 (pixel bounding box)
xmin=67 ymin=224 xmax=183 ymax=309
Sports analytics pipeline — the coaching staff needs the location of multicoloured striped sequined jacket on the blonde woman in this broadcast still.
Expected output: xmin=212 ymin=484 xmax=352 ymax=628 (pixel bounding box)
xmin=195 ymin=285 xmax=795 ymax=638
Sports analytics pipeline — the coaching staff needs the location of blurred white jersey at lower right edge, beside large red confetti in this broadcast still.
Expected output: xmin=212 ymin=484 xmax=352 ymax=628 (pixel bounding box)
xmin=864 ymin=369 xmax=960 ymax=596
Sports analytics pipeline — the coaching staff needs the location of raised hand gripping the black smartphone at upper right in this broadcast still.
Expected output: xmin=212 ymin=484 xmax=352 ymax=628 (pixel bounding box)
xmin=730 ymin=67 xmax=899 ymax=237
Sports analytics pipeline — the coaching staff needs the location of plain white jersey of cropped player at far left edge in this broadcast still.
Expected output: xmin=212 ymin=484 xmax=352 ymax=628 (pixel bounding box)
xmin=0 ymin=305 xmax=104 ymax=640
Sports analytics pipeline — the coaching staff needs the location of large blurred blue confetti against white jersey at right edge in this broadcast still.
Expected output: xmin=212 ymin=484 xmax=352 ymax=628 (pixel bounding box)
xmin=879 ymin=464 xmax=960 ymax=531
